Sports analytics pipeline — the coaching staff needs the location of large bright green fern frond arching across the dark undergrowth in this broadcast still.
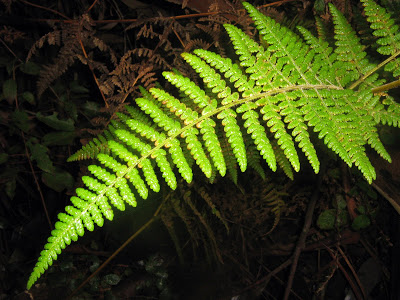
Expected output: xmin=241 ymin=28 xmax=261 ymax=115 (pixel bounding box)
xmin=27 ymin=0 xmax=400 ymax=289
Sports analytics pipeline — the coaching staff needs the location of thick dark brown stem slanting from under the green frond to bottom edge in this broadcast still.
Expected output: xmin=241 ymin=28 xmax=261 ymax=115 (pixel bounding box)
xmin=283 ymin=175 xmax=322 ymax=300
